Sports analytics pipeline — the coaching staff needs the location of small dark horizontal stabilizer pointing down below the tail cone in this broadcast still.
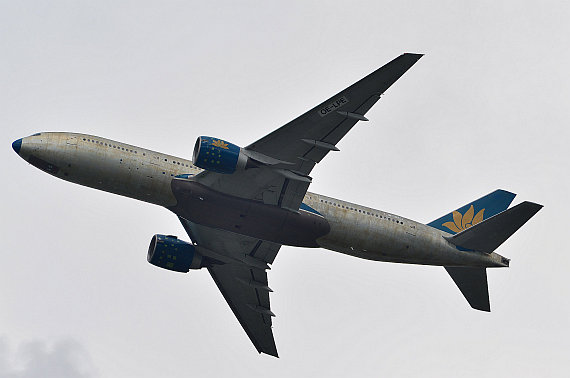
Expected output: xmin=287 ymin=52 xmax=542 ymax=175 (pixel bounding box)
xmin=445 ymin=266 xmax=491 ymax=312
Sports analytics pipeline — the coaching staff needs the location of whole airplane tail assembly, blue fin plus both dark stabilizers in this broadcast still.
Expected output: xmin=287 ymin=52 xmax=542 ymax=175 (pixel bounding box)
xmin=428 ymin=189 xmax=542 ymax=311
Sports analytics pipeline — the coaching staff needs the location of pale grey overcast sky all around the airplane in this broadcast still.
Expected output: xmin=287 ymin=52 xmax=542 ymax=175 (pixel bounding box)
xmin=0 ymin=0 xmax=570 ymax=378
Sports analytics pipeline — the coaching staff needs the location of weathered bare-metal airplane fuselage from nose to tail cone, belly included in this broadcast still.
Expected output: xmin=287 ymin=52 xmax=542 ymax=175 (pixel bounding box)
xmin=18 ymin=132 xmax=506 ymax=267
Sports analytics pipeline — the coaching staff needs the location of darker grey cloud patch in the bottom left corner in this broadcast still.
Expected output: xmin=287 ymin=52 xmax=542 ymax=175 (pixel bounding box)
xmin=0 ymin=337 xmax=96 ymax=378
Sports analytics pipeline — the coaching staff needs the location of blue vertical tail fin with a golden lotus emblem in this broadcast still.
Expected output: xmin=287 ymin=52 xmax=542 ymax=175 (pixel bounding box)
xmin=428 ymin=189 xmax=516 ymax=234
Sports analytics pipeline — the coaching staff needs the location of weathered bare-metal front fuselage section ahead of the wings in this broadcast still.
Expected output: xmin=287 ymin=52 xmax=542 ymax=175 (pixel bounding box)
xmin=14 ymin=133 xmax=202 ymax=206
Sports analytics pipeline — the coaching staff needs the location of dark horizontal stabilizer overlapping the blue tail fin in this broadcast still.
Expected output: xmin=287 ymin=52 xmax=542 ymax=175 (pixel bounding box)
xmin=445 ymin=202 xmax=542 ymax=253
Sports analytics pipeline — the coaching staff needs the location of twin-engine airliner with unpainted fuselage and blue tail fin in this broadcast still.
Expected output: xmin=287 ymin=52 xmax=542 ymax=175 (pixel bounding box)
xmin=12 ymin=53 xmax=542 ymax=357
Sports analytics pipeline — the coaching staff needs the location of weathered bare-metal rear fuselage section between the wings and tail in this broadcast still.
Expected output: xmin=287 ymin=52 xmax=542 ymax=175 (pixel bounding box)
xmin=304 ymin=193 xmax=505 ymax=266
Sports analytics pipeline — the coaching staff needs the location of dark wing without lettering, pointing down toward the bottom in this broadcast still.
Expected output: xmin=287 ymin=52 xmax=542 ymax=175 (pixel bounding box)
xmin=179 ymin=218 xmax=281 ymax=357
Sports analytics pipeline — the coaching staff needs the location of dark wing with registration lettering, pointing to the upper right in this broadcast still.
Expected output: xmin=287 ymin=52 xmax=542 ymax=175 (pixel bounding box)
xmin=196 ymin=54 xmax=422 ymax=211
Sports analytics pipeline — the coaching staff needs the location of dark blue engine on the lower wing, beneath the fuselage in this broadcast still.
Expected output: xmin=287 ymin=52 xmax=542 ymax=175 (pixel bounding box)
xmin=147 ymin=235 xmax=203 ymax=273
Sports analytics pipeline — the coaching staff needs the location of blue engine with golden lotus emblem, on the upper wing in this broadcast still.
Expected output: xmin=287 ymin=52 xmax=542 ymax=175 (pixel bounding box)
xmin=192 ymin=136 xmax=248 ymax=174
